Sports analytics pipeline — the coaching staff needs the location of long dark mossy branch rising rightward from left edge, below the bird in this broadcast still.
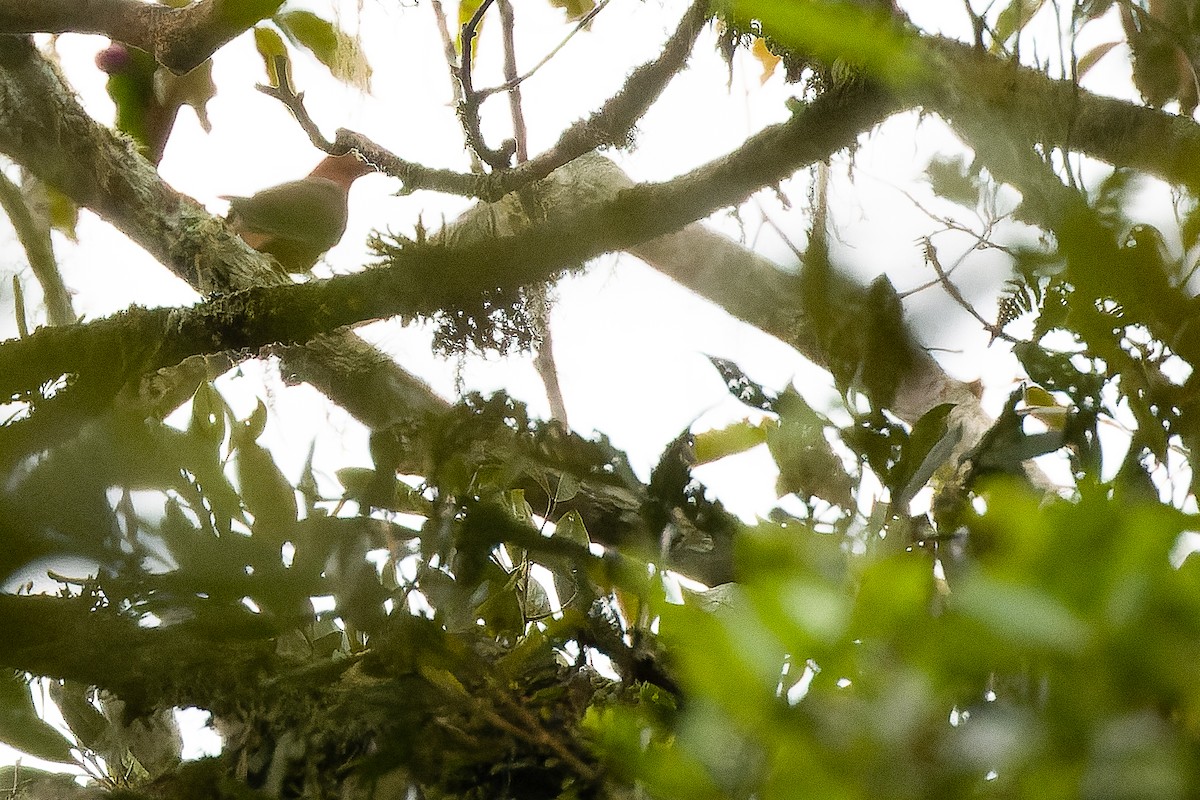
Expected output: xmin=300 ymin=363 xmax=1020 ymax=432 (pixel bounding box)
xmin=0 ymin=88 xmax=892 ymax=407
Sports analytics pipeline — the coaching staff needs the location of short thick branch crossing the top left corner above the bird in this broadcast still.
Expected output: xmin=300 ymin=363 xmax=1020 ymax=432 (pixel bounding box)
xmin=0 ymin=0 xmax=283 ymax=74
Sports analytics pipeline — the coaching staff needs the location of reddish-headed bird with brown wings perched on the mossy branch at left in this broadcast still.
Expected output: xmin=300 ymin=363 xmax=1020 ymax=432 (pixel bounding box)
xmin=222 ymin=154 xmax=373 ymax=275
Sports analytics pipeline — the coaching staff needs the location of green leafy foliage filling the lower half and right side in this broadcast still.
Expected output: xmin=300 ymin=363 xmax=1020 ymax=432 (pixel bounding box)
xmin=9 ymin=0 xmax=1200 ymax=800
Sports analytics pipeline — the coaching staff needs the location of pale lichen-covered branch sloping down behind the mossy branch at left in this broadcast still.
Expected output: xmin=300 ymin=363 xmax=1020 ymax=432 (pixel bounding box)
xmin=0 ymin=37 xmax=444 ymax=462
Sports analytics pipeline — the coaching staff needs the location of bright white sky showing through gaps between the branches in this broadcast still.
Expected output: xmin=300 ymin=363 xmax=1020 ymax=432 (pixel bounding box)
xmin=0 ymin=0 xmax=1169 ymax=777
